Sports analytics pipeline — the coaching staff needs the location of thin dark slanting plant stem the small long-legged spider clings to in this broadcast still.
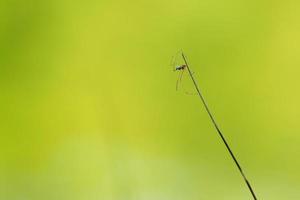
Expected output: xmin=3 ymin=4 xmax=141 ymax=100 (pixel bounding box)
xmin=182 ymin=53 xmax=257 ymax=200
